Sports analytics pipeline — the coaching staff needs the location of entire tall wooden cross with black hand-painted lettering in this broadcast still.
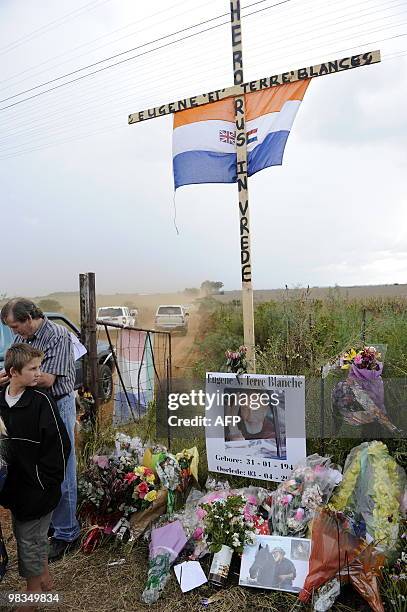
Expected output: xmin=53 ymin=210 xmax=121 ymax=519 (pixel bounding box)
xmin=128 ymin=0 xmax=380 ymax=372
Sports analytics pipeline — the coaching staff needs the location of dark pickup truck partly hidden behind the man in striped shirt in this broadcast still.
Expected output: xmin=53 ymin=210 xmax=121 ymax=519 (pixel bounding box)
xmin=0 ymin=312 xmax=114 ymax=402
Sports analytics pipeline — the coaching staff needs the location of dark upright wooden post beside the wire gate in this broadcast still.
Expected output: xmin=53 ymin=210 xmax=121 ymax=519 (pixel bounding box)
xmin=79 ymin=272 xmax=99 ymax=423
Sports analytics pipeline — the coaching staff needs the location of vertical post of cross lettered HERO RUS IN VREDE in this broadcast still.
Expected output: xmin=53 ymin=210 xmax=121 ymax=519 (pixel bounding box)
xmin=230 ymin=0 xmax=256 ymax=372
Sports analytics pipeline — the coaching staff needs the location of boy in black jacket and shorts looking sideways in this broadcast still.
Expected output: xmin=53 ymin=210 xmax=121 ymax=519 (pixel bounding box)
xmin=0 ymin=344 xmax=71 ymax=611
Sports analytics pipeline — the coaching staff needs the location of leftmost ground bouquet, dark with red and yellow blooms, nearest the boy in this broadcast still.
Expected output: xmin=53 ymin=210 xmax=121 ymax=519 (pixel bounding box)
xmin=78 ymin=455 xmax=157 ymax=552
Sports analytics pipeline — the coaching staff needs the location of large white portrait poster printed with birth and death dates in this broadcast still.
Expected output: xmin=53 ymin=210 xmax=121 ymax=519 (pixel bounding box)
xmin=205 ymin=372 xmax=306 ymax=482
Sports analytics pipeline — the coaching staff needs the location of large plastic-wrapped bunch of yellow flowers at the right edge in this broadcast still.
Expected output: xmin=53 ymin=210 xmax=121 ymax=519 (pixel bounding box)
xmin=332 ymin=441 xmax=406 ymax=552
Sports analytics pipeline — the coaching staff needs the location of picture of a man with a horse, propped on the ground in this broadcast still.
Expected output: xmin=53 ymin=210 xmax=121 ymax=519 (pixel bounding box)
xmin=239 ymin=535 xmax=311 ymax=593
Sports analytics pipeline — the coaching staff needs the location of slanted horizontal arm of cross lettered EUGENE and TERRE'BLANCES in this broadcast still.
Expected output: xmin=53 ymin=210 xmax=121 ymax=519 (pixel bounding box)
xmin=128 ymin=51 xmax=380 ymax=124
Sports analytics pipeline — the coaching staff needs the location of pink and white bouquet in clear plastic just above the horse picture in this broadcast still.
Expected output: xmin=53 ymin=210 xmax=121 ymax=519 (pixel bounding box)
xmin=271 ymin=455 xmax=342 ymax=537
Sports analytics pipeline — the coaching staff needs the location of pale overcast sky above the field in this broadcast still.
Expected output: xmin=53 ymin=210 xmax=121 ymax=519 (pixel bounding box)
xmin=0 ymin=0 xmax=407 ymax=295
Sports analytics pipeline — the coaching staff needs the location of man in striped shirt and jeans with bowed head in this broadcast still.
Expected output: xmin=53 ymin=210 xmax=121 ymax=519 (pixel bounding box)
xmin=0 ymin=298 xmax=80 ymax=561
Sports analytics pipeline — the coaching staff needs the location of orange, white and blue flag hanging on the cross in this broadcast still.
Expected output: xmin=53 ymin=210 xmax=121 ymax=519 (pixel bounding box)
xmin=173 ymin=79 xmax=310 ymax=189
